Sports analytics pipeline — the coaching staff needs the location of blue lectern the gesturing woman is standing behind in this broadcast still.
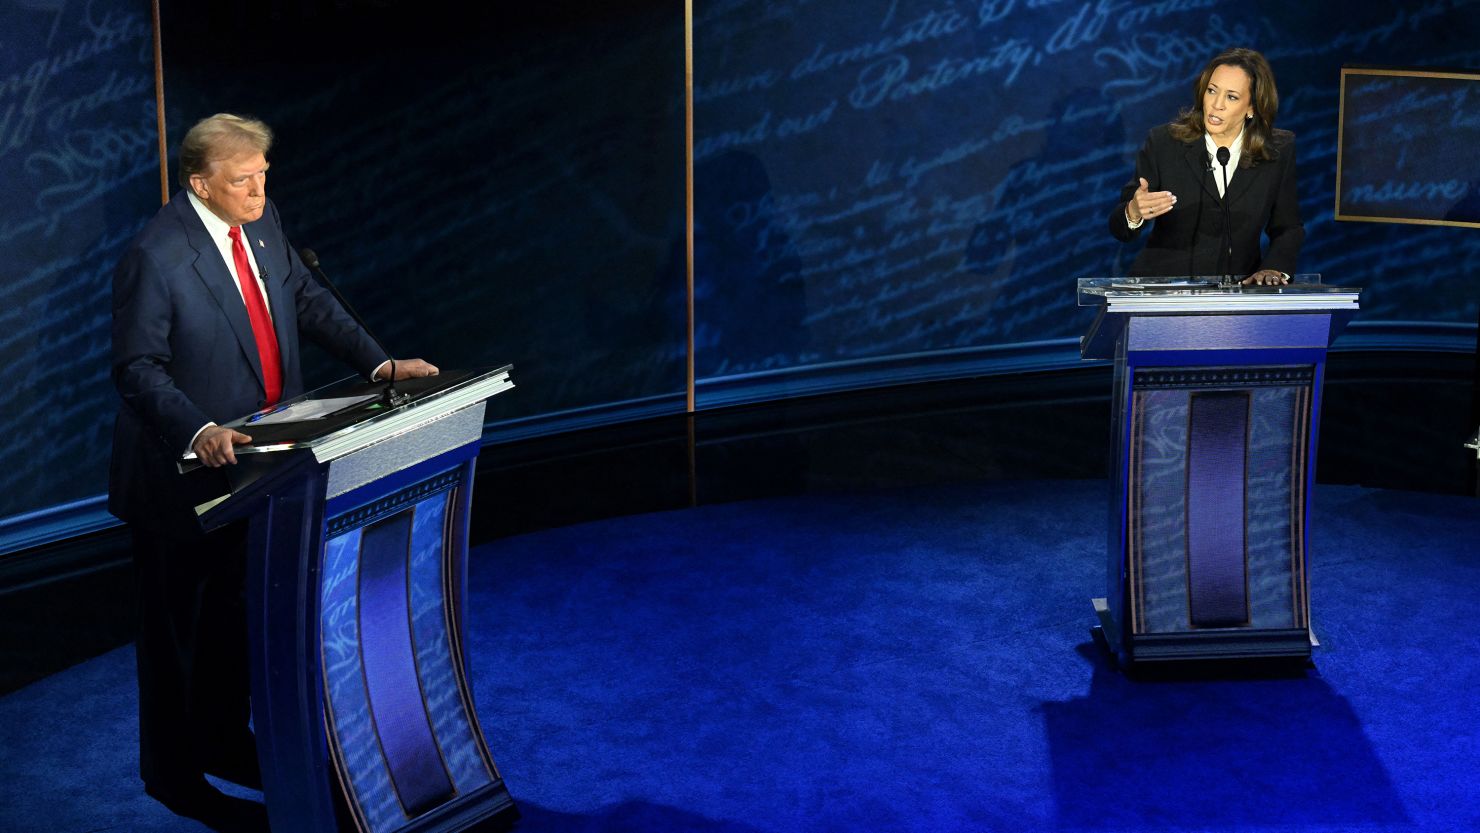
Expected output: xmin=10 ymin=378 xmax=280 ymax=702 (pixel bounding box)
xmin=1079 ymin=275 xmax=1360 ymax=666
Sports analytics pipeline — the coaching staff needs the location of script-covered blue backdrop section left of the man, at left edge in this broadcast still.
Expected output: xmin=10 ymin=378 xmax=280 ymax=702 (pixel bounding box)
xmin=0 ymin=0 xmax=160 ymax=552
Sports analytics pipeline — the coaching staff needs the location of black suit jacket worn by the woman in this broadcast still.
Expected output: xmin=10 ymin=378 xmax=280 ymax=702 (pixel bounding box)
xmin=1110 ymin=124 xmax=1305 ymax=278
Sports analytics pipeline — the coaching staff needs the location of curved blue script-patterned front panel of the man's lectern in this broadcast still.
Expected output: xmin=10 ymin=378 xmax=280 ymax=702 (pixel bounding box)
xmin=323 ymin=468 xmax=496 ymax=833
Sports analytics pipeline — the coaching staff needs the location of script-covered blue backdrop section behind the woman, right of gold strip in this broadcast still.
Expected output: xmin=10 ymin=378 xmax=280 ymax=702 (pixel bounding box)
xmin=694 ymin=0 xmax=1480 ymax=399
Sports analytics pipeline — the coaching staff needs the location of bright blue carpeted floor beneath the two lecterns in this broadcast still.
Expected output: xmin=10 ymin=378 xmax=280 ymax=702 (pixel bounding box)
xmin=0 ymin=481 xmax=1480 ymax=833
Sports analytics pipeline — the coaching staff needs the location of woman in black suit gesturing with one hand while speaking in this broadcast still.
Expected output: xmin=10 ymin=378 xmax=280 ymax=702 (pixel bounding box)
xmin=1110 ymin=49 xmax=1305 ymax=284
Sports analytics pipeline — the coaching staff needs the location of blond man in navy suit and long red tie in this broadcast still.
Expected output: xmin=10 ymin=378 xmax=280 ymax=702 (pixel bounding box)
xmin=108 ymin=114 xmax=437 ymax=824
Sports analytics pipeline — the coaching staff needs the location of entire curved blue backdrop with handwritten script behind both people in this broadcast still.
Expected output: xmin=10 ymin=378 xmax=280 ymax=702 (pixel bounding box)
xmin=0 ymin=0 xmax=1480 ymax=549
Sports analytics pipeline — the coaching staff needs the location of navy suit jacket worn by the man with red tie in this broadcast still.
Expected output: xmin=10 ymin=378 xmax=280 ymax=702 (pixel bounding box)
xmin=108 ymin=191 xmax=386 ymax=534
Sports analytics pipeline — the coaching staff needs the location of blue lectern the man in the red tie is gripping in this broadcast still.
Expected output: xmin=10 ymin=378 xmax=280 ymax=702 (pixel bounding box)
xmin=182 ymin=367 xmax=518 ymax=833
